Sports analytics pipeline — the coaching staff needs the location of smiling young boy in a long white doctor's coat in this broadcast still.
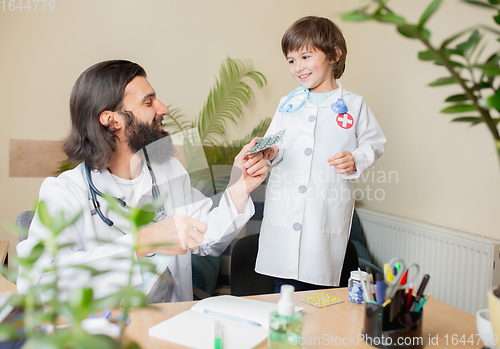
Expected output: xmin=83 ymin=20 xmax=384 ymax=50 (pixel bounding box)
xmin=255 ymin=17 xmax=386 ymax=290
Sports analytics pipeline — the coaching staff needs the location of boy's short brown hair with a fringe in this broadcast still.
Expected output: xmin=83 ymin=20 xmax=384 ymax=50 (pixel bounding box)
xmin=281 ymin=16 xmax=347 ymax=79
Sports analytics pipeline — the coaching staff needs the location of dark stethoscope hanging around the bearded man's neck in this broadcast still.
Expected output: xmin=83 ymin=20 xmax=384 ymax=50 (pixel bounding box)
xmin=85 ymin=148 xmax=167 ymax=232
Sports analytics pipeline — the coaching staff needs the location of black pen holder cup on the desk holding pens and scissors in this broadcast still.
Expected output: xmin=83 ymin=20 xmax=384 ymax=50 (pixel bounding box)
xmin=363 ymin=302 xmax=424 ymax=349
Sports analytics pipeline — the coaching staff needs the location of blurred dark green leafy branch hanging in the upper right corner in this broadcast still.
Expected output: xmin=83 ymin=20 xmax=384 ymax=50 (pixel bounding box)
xmin=342 ymin=0 xmax=500 ymax=169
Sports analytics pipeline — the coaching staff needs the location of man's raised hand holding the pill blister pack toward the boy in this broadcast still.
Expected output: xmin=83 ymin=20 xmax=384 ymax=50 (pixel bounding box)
xmin=228 ymin=137 xmax=267 ymax=212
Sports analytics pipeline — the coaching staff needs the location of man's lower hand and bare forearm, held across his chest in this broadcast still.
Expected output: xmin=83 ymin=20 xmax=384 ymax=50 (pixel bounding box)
xmin=137 ymin=216 xmax=207 ymax=257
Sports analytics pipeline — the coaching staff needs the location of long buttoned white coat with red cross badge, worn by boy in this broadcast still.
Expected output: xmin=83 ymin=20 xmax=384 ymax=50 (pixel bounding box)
xmin=255 ymin=82 xmax=386 ymax=286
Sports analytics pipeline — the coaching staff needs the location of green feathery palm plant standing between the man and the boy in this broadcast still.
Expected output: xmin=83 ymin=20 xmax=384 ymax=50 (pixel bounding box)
xmin=163 ymin=57 xmax=271 ymax=195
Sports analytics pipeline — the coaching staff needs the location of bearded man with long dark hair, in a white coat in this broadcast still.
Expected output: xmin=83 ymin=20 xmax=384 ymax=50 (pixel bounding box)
xmin=17 ymin=60 xmax=267 ymax=302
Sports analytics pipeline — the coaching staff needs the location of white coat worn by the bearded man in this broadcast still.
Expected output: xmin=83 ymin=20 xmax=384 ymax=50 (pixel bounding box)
xmin=17 ymin=158 xmax=254 ymax=301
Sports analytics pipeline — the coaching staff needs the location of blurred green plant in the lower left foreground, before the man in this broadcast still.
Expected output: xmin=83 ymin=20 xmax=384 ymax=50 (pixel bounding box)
xmin=0 ymin=195 xmax=156 ymax=349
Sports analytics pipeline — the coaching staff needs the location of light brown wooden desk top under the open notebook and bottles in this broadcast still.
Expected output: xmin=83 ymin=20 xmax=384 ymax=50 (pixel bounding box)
xmin=125 ymin=288 xmax=483 ymax=349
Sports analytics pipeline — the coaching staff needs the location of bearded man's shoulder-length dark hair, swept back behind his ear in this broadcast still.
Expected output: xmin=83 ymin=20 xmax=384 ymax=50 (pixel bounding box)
xmin=63 ymin=60 xmax=146 ymax=170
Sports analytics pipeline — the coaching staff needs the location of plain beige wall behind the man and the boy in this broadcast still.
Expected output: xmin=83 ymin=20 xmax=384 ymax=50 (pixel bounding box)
xmin=0 ymin=0 xmax=500 ymax=260
